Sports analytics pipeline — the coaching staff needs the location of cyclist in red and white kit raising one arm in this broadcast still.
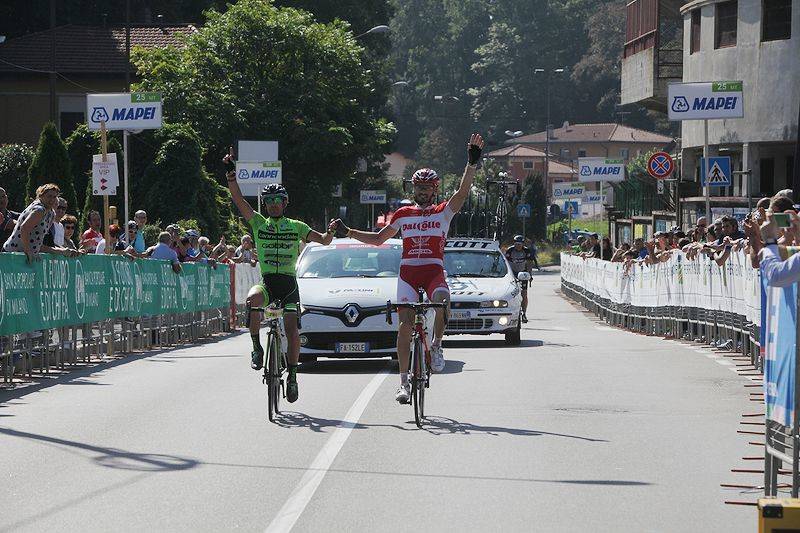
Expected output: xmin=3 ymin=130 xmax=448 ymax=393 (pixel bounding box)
xmin=335 ymin=133 xmax=483 ymax=403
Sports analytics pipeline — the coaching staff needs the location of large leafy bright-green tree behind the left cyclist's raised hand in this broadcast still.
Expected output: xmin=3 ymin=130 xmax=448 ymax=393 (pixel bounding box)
xmin=134 ymin=0 xmax=394 ymax=220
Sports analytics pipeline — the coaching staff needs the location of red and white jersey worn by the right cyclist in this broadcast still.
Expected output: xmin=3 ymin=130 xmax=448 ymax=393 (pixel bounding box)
xmin=389 ymin=202 xmax=454 ymax=266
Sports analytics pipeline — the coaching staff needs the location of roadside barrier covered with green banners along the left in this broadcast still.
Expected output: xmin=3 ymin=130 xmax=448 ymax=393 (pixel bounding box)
xmin=0 ymin=253 xmax=231 ymax=383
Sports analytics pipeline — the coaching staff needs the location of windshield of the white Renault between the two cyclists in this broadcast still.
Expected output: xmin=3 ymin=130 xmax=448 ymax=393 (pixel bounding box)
xmin=297 ymin=244 xmax=402 ymax=278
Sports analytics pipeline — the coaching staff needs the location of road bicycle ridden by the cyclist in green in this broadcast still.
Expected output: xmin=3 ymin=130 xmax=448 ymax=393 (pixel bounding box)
xmin=247 ymin=301 xmax=287 ymax=422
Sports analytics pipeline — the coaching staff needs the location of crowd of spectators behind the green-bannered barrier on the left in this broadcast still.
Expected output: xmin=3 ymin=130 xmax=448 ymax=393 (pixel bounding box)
xmin=0 ymin=183 xmax=258 ymax=272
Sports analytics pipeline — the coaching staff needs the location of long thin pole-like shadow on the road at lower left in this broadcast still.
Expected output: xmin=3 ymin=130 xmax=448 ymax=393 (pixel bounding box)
xmin=0 ymin=427 xmax=200 ymax=472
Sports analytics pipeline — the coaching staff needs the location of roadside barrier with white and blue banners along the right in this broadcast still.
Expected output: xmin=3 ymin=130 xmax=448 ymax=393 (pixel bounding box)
xmin=561 ymin=252 xmax=800 ymax=498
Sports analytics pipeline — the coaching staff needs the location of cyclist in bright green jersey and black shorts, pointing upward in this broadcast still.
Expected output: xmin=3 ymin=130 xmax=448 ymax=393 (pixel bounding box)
xmin=223 ymin=151 xmax=333 ymax=402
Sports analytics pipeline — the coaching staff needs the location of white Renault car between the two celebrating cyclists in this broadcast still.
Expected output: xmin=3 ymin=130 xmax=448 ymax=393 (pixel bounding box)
xmin=297 ymin=239 xmax=403 ymax=361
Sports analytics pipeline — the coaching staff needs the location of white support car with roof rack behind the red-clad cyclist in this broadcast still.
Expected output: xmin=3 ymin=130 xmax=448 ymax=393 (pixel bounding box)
xmin=444 ymin=238 xmax=527 ymax=346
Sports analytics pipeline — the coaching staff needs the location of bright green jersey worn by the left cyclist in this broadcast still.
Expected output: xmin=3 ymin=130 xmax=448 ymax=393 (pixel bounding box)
xmin=250 ymin=213 xmax=311 ymax=276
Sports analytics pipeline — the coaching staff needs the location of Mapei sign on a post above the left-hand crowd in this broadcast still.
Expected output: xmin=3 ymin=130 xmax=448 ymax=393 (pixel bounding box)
xmin=86 ymin=93 xmax=162 ymax=130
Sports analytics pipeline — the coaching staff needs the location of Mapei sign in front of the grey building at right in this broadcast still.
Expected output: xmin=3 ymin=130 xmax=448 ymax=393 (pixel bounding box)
xmin=667 ymin=81 xmax=744 ymax=120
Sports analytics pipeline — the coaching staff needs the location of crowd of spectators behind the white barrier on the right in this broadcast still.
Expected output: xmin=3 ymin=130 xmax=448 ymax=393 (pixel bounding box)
xmin=570 ymin=189 xmax=800 ymax=272
